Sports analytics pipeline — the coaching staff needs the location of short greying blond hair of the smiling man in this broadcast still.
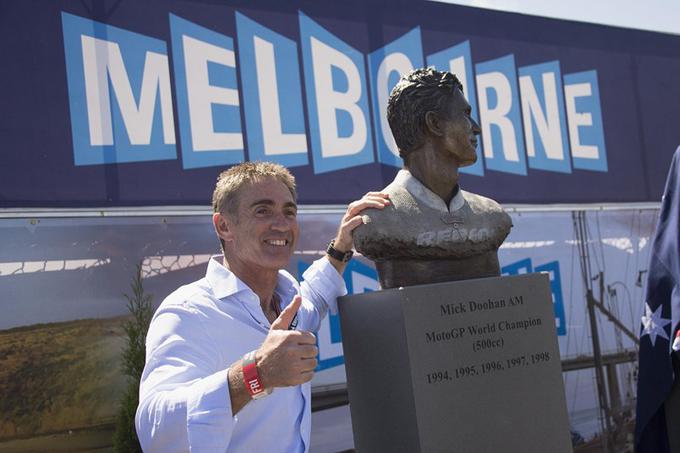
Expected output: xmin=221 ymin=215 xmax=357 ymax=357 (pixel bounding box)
xmin=212 ymin=162 xmax=297 ymax=215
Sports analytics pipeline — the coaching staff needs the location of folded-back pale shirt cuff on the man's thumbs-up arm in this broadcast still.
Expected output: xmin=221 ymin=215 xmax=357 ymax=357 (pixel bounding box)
xmin=187 ymin=369 xmax=235 ymax=452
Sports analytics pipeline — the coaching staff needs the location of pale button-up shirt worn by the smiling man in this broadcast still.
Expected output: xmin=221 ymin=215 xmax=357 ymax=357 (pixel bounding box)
xmin=135 ymin=256 xmax=347 ymax=453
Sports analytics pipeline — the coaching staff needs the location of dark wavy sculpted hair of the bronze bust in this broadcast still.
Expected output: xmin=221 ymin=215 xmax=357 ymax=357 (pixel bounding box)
xmin=387 ymin=68 xmax=463 ymax=162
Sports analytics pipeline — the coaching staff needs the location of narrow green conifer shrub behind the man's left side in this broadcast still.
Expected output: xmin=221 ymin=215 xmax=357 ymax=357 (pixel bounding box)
xmin=113 ymin=264 xmax=153 ymax=453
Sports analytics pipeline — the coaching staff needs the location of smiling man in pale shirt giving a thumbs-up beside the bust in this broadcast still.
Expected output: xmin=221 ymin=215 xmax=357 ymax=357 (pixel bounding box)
xmin=136 ymin=162 xmax=389 ymax=453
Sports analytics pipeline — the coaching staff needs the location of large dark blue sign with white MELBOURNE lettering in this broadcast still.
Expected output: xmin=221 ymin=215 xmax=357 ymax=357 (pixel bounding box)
xmin=0 ymin=0 xmax=680 ymax=207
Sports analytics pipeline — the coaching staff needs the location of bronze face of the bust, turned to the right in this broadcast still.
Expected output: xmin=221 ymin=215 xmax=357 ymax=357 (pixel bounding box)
xmin=442 ymin=88 xmax=481 ymax=167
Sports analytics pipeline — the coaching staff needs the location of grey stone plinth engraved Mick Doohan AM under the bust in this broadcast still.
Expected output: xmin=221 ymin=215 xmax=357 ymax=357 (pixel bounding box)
xmin=338 ymin=274 xmax=572 ymax=453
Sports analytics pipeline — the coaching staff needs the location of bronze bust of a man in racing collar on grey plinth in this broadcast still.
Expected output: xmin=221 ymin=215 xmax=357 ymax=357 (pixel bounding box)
xmin=354 ymin=68 xmax=512 ymax=289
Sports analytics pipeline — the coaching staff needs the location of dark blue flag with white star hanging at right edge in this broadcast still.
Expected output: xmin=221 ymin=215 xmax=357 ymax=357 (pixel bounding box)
xmin=635 ymin=148 xmax=680 ymax=453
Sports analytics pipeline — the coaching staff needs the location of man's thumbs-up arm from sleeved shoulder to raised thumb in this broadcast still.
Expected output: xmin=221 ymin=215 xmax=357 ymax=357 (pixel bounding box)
xmin=136 ymin=297 xmax=318 ymax=452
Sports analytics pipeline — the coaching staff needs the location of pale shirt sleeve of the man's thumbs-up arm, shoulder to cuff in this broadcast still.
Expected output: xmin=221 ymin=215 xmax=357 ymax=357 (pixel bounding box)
xmin=135 ymin=303 xmax=236 ymax=452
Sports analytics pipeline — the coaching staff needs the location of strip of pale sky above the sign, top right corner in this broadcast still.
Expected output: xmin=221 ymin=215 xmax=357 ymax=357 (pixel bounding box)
xmin=436 ymin=0 xmax=680 ymax=35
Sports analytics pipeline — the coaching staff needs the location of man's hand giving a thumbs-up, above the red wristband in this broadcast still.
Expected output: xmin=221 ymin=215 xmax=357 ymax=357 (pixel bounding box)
xmin=255 ymin=296 xmax=319 ymax=388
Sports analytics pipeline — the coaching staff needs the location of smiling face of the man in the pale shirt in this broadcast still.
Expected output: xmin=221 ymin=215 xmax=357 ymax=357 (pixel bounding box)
xmin=223 ymin=178 xmax=299 ymax=272
